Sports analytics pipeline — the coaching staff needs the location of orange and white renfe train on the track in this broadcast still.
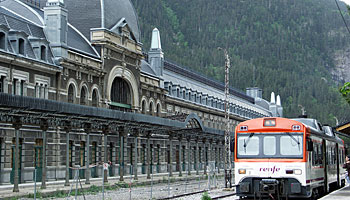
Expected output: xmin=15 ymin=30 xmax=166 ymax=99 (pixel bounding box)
xmin=234 ymin=117 xmax=346 ymax=199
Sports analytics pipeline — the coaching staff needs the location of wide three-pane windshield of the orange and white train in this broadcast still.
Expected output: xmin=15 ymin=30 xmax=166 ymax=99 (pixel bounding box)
xmin=237 ymin=132 xmax=304 ymax=158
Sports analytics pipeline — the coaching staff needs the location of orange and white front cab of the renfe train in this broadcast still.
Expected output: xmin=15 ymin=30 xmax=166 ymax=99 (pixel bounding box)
xmin=235 ymin=118 xmax=312 ymax=199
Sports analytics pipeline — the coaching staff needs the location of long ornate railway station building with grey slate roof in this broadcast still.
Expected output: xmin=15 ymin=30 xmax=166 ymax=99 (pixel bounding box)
xmin=0 ymin=0 xmax=283 ymax=191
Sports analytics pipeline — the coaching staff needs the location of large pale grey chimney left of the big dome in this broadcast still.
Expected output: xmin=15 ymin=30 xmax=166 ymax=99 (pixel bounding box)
xmin=44 ymin=0 xmax=68 ymax=57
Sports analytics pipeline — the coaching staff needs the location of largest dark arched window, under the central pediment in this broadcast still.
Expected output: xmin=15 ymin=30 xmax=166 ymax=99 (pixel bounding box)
xmin=111 ymin=77 xmax=131 ymax=111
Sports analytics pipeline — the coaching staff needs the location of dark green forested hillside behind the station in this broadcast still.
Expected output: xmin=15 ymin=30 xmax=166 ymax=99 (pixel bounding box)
xmin=132 ymin=0 xmax=350 ymax=125
